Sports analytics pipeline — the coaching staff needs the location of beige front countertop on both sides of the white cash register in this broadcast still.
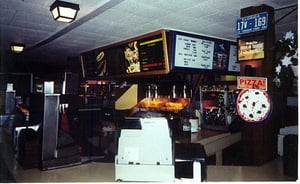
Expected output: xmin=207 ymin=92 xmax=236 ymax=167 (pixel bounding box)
xmin=1 ymin=127 xmax=295 ymax=183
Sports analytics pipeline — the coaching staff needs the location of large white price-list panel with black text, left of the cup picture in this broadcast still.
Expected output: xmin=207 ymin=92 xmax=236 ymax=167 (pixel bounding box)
xmin=174 ymin=35 xmax=214 ymax=70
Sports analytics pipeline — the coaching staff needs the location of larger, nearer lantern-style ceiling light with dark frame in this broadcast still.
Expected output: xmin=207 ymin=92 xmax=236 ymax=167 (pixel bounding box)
xmin=50 ymin=0 xmax=79 ymax=23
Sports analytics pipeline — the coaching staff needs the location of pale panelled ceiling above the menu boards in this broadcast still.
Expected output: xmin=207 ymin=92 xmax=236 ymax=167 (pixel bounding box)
xmin=0 ymin=0 xmax=298 ymax=67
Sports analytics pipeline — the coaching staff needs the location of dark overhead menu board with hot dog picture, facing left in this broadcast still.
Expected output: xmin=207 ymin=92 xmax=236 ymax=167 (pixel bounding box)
xmin=80 ymin=29 xmax=170 ymax=79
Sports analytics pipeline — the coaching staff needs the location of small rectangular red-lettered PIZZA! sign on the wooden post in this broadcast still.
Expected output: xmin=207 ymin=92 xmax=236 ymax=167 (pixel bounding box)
xmin=237 ymin=76 xmax=268 ymax=91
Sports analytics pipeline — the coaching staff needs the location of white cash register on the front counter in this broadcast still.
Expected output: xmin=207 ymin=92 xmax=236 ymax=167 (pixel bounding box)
xmin=115 ymin=117 xmax=175 ymax=182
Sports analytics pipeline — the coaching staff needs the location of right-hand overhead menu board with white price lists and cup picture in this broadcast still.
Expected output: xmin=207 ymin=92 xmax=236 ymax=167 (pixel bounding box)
xmin=171 ymin=31 xmax=240 ymax=73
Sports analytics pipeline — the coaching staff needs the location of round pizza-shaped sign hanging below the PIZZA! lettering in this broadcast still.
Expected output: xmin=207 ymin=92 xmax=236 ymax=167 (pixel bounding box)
xmin=236 ymin=89 xmax=272 ymax=123
